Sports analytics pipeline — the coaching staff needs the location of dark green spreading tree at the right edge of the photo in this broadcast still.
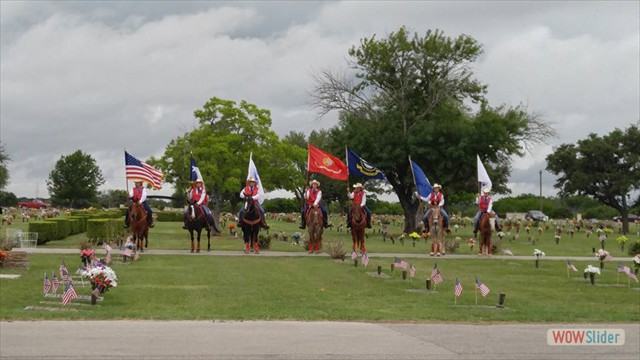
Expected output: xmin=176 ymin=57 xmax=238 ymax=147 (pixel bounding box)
xmin=547 ymin=125 xmax=640 ymax=233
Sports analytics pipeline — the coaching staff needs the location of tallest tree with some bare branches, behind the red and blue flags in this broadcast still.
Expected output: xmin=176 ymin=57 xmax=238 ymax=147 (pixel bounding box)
xmin=312 ymin=27 xmax=553 ymax=232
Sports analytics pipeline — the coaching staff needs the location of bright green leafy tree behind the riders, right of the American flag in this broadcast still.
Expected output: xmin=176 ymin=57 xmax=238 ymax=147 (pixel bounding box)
xmin=150 ymin=97 xmax=305 ymax=218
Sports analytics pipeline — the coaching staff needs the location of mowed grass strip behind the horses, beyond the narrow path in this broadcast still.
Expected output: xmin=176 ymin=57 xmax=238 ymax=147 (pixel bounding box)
xmin=28 ymin=215 xmax=640 ymax=260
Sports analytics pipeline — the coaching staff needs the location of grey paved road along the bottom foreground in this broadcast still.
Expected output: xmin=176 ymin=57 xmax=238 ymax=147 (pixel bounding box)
xmin=0 ymin=321 xmax=640 ymax=360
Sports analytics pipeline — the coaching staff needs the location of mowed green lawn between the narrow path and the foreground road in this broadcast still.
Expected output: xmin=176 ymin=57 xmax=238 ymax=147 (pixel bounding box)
xmin=0 ymin=252 xmax=640 ymax=323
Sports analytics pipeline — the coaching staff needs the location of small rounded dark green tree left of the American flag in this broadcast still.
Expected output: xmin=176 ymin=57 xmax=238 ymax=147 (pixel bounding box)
xmin=47 ymin=150 xmax=104 ymax=208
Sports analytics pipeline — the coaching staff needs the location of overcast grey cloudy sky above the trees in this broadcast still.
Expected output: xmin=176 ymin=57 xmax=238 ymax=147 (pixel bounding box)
xmin=0 ymin=0 xmax=640 ymax=197
